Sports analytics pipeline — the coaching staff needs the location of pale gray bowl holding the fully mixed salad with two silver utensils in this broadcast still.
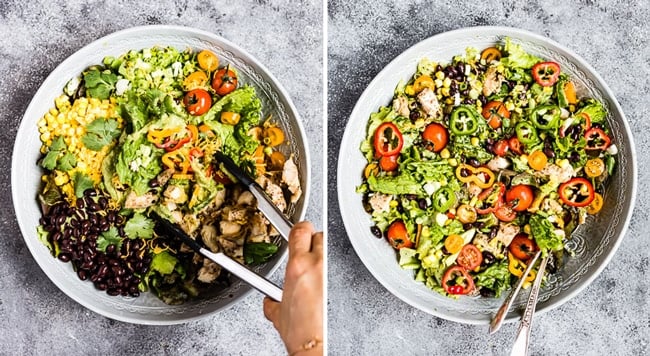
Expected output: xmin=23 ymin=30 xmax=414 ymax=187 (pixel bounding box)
xmin=338 ymin=27 xmax=637 ymax=324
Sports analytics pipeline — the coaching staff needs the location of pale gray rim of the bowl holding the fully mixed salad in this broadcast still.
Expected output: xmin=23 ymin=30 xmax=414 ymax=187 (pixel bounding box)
xmin=337 ymin=26 xmax=638 ymax=324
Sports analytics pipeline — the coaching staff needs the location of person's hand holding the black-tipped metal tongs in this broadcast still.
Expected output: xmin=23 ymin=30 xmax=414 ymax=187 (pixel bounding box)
xmin=264 ymin=221 xmax=323 ymax=356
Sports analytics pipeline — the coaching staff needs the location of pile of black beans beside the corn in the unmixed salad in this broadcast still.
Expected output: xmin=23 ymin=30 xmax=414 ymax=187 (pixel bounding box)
xmin=40 ymin=189 xmax=151 ymax=297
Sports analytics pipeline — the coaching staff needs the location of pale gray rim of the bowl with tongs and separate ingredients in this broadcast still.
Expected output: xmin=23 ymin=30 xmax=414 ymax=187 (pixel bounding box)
xmin=11 ymin=25 xmax=311 ymax=325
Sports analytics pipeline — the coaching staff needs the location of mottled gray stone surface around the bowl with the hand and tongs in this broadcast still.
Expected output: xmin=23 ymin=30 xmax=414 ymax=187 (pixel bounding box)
xmin=0 ymin=0 xmax=323 ymax=355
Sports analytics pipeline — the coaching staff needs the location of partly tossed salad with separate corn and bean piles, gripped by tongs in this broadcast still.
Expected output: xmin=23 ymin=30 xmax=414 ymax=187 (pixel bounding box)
xmin=38 ymin=47 xmax=302 ymax=304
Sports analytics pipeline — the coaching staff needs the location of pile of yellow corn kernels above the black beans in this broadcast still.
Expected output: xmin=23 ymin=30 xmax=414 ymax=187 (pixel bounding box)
xmin=38 ymin=94 xmax=122 ymax=202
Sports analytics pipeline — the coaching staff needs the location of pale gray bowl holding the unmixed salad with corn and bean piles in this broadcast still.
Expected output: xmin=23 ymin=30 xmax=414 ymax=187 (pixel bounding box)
xmin=11 ymin=26 xmax=310 ymax=324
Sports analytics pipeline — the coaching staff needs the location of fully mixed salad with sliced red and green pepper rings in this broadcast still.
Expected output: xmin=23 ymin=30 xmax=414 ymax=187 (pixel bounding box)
xmin=358 ymin=38 xmax=617 ymax=297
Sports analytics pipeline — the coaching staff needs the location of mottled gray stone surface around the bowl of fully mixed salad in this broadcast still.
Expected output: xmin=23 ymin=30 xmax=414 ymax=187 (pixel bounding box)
xmin=327 ymin=0 xmax=650 ymax=355
